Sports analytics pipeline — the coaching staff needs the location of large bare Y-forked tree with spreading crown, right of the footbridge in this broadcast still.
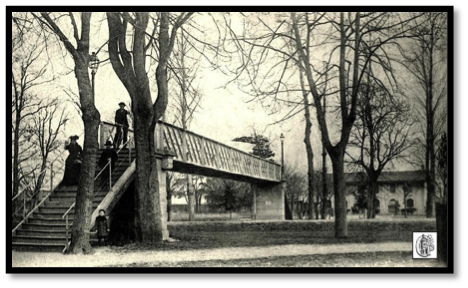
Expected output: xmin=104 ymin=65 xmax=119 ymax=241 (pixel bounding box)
xmin=227 ymin=12 xmax=417 ymax=238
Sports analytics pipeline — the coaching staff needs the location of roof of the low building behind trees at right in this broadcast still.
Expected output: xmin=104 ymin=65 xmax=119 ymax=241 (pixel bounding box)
xmin=328 ymin=170 xmax=426 ymax=184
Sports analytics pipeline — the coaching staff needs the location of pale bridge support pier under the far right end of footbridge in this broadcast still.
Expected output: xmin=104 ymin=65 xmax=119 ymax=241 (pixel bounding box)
xmin=252 ymin=182 xmax=286 ymax=220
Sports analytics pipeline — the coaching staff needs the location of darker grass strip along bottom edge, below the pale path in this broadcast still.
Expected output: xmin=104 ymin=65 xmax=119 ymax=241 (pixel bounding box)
xmin=107 ymin=252 xmax=443 ymax=267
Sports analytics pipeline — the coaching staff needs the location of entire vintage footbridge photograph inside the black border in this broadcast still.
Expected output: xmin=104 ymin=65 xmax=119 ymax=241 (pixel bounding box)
xmin=11 ymin=12 xmax=447 ymax=267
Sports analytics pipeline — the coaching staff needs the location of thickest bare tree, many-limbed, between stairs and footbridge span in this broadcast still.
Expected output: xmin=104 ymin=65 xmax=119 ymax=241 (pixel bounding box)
xmin=107 ymin=12 xmax=193 ymax=243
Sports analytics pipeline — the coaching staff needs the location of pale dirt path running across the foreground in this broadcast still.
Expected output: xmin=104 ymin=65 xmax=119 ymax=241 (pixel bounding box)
xmin=11 ymin=242 xmax=412 ymax=267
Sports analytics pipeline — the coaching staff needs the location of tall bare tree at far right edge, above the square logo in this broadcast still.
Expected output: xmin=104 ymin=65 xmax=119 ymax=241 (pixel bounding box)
xmin=400 ymin=12 xmax=447 ymax=217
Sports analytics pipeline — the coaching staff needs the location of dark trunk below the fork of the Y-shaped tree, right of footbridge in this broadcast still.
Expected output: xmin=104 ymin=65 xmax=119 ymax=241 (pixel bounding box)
xmin=331 ymin=153 xmax=348 ymax=238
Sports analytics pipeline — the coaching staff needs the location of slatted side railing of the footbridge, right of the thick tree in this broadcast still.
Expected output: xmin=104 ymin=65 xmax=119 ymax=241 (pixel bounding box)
xmin=156 ymin=121 xmax=281 ymax=182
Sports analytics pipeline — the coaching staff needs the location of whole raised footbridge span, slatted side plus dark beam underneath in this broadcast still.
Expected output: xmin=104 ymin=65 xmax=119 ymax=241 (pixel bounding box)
xmin=100 ymin=121 xmax=281 ymax=183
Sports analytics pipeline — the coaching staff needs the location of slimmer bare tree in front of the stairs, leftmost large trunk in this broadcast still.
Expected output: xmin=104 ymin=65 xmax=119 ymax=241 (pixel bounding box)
xmin=32 ymin=12 xmax=100 ymax=254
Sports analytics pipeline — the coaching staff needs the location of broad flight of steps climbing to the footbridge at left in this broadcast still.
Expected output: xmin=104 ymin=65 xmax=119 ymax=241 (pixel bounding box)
xmin=11 ymin=149 xmax=135 ymax=252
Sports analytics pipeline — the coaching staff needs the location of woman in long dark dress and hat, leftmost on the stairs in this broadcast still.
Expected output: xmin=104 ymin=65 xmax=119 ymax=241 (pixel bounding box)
xmin=61 ymin=135 xmax=83 ymax=186
